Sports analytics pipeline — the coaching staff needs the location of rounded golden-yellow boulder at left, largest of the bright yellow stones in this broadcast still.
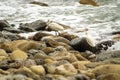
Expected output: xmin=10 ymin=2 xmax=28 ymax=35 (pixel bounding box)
xmin=10 ymin=50 xmax=28 ymax=60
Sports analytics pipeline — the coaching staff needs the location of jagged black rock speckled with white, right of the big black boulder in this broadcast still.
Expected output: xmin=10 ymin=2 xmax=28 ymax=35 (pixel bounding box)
xmin=95 ymin=40 xmax=114 ymax=53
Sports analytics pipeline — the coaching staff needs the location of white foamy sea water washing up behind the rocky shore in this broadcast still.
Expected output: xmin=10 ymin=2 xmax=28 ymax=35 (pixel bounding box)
xmin=0 ymin=0 xmax=120 ymax=49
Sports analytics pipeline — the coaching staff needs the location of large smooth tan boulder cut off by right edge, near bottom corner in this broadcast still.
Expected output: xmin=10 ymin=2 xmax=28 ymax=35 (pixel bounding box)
xmin=91 ymin=64 xmax=120 ymax=76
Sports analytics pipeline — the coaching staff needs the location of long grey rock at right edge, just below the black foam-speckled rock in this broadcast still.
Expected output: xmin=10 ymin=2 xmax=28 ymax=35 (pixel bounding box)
xmin=95 ymin=50 xmax=120 ymax=61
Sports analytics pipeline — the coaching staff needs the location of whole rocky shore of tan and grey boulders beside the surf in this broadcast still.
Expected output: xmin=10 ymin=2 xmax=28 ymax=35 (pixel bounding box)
xmin=0 ymin=20 xmax=120 ymax=80
